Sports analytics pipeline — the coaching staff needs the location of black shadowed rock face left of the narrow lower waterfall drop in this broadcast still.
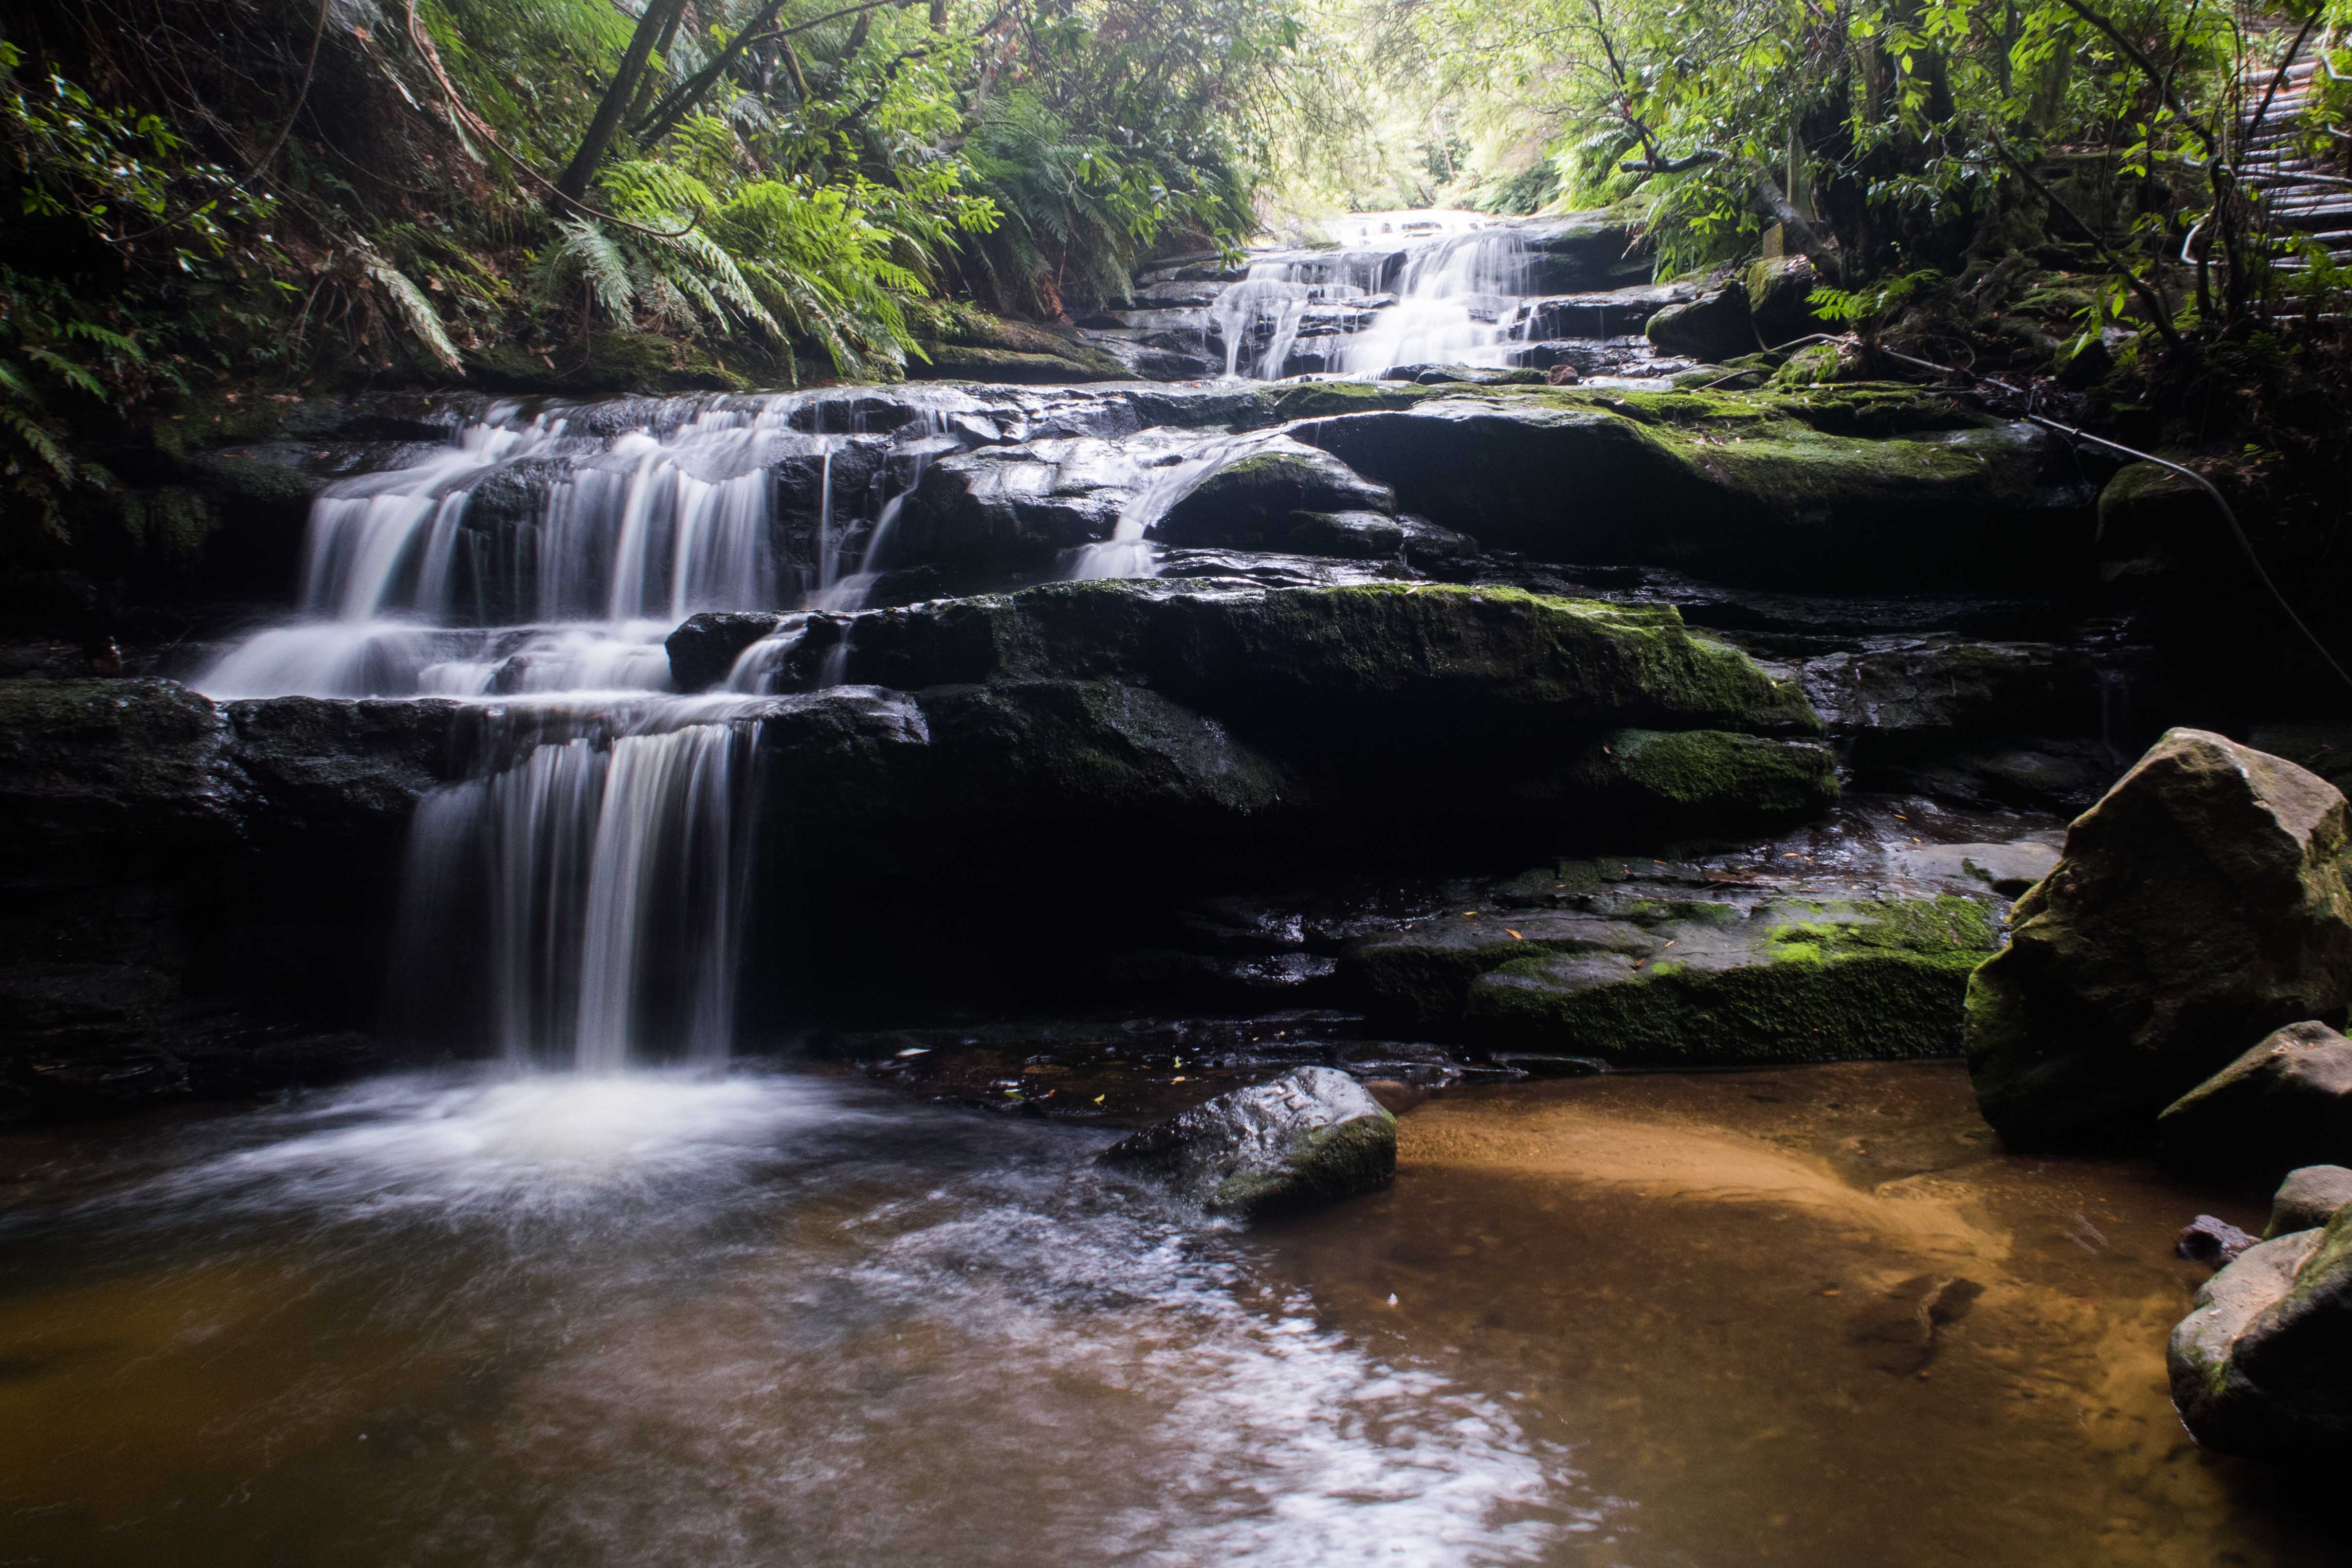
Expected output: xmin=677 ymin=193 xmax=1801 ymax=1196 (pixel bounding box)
xmin=0 ymin=679 xmax=458 ymax=1117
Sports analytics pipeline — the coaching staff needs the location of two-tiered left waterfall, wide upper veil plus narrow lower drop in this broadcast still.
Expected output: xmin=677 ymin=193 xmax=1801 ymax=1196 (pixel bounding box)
xmin=190 ymin=393 xmax=964 ymax=1072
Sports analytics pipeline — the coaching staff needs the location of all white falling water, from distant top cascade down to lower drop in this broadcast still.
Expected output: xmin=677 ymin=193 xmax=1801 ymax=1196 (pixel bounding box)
xmin=190 ymin=214 xmax=1580 ymax=1072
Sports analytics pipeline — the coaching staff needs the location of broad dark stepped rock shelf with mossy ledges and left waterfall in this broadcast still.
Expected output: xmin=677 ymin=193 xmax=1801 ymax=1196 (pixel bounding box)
xmin=0 ymin=346 xmax=2164 ymax=1110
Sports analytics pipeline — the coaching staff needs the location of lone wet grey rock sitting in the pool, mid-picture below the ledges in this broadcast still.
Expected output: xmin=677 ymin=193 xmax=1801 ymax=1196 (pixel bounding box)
xmin=1101 ymin=1067 xmax=1397 ymax=1220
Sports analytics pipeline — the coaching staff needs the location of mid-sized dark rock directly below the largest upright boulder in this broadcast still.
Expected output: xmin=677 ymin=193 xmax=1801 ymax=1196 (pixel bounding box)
xmin=2157 ymin=1022 xmax=2352 ymax=1183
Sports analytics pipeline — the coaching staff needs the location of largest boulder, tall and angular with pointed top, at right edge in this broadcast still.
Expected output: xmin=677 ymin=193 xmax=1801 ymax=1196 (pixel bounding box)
xmin=1969 ymin=729 xmax=2352 ymax=1147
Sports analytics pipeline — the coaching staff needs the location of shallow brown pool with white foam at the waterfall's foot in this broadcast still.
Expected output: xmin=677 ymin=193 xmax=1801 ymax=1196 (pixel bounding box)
xmin=0 ymin=1062 xmax=2340 ymax=1568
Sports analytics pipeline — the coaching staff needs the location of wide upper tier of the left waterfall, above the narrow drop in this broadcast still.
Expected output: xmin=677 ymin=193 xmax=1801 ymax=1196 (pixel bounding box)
xmin=188 ymin=390 xmax=969 ymax=698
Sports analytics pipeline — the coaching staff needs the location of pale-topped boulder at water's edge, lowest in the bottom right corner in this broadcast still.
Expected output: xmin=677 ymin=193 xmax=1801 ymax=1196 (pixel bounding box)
xmin=2169 ymin=1208 xmax=2352 ymax=1462
